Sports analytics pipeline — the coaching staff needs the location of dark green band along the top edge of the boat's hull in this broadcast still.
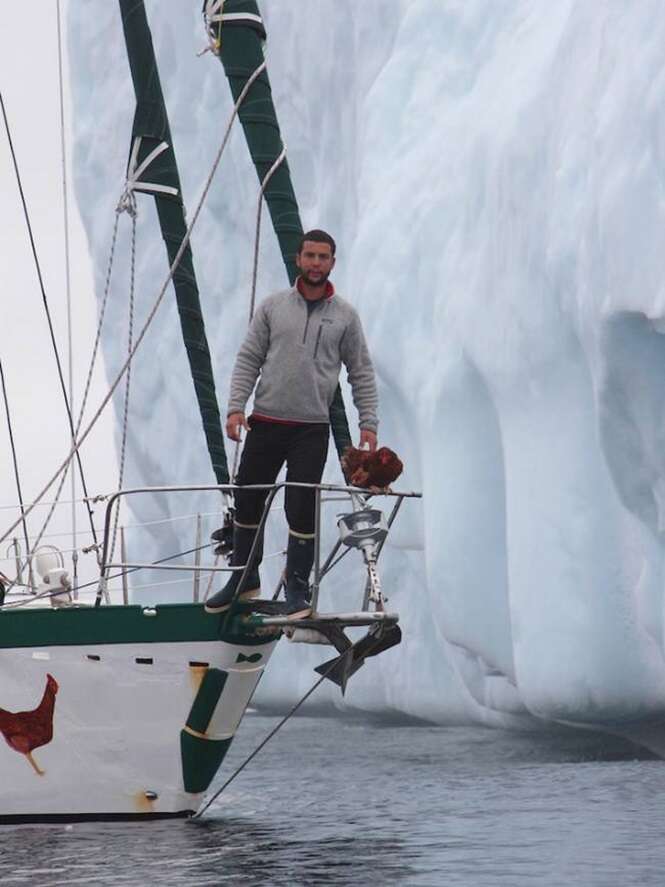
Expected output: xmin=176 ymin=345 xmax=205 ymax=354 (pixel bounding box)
xmin=0 ymin=604 xmax=271 ymax=649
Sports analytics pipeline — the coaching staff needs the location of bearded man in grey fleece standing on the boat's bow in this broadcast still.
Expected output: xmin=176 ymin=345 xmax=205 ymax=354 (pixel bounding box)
xmin=205 ymin=230 xmax=378 ymax=619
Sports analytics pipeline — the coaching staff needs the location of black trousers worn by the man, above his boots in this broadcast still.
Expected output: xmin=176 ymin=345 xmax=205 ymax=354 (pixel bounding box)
xmin=235 ymin=418 xmax=330 ymax=535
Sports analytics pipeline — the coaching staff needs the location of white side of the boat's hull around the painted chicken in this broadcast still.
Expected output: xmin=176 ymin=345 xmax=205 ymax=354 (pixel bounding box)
xmin=0 ymin=641 xmax=274 ymax=820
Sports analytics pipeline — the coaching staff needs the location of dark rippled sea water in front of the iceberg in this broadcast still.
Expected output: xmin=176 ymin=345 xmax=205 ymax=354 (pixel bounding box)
xmin=0 ymin=716 xmax=665 ymax=887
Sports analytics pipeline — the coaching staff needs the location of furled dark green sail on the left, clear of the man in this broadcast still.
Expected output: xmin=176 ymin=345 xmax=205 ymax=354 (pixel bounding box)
xmin=119 ymin=0 xmax=229 ymax=484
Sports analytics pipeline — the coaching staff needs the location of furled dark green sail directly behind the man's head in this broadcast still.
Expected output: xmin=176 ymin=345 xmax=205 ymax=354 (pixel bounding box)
xmin=203 ymin=0 xmax=351 ymax=456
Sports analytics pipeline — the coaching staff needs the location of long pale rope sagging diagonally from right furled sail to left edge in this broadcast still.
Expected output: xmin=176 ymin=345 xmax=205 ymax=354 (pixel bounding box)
xmin=0 ymin=60 xmax=266 ymax=542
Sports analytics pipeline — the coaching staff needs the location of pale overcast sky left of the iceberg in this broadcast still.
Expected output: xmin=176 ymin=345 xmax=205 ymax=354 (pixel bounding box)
xmin=0 ymin=6 xmax=117 ymax=588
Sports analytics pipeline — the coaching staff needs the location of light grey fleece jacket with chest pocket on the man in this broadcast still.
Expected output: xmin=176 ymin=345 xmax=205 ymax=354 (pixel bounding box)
xmin=228 ymin=287 xmax=378 ymax=431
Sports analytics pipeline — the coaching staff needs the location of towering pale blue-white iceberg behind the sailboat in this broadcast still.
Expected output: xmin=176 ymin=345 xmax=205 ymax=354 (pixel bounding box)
xmin=68 ymin=0 xmax=665 ymax=744
